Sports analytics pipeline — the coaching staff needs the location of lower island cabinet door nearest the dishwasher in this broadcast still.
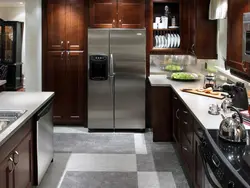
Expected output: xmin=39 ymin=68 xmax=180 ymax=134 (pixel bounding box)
xmin=13 ymin=133 xmax=32 ymax=188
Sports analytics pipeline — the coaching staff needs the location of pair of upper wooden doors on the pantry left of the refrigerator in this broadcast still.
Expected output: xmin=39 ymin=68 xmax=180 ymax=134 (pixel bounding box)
xmin=47 ymin=0 xmax=84 ymax=50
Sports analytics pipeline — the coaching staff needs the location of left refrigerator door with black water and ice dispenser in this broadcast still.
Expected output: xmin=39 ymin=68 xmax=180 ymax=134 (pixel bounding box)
xmin=88 ymin=29 xmax=114 ymax=129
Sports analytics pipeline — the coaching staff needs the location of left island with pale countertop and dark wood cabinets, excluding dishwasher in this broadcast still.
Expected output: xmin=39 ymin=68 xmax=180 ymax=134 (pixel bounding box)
xmin=0 ymin=92 xmax=54 ymax=188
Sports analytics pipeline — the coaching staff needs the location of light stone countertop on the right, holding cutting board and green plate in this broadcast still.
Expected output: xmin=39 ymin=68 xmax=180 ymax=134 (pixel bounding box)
xmin=149 ymin=75 xmax=250 ymax=129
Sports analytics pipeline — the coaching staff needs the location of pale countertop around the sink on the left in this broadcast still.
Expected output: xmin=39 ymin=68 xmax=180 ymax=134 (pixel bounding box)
xmin=0 ymin=92 xmax=54 ymax=146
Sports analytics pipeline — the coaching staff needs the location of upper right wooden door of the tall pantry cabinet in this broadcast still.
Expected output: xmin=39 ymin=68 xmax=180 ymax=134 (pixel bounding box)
xmin=66 ymin=0 xmax=85 ymax=50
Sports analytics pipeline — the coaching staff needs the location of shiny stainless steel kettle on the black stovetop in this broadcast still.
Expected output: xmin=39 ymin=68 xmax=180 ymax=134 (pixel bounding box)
xmin=219 ymin=106 xmax=247 ymax=143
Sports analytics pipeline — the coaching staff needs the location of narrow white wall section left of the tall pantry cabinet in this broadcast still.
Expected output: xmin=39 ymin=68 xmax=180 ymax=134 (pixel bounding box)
xmin=25 ymin=0 xmax=42 ymax=91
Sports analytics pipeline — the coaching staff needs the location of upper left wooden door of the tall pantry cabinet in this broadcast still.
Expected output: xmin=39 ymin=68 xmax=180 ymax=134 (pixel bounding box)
xmin=46 ymin=0 xmax=66 ymax=50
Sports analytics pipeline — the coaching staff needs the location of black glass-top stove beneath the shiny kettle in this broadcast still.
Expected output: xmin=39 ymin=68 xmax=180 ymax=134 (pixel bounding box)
xmin=196 ymin=129 xmax=250 ymax=188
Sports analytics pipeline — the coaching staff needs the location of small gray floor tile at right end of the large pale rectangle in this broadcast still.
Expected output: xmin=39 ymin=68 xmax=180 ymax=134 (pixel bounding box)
xmin=136 ymin=154 xmax=155 ymax=172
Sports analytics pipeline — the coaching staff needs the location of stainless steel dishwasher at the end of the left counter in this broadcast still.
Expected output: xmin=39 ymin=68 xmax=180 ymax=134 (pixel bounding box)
xmin=35 ymin=100 xmax=54 ymax=185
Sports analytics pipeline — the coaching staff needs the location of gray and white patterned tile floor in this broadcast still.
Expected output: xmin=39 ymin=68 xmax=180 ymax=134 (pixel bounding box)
xmin=38 ymin=127 xmax=189 ymax=188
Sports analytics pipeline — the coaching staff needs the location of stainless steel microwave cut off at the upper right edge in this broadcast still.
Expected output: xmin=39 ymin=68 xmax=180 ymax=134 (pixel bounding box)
xmin=242 ymin=13 xmax=250 ymax=63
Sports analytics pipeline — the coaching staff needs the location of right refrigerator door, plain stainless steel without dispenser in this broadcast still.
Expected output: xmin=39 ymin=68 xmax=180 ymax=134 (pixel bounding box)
xmin=110 ymin=29 xmax=146 ymax=129
